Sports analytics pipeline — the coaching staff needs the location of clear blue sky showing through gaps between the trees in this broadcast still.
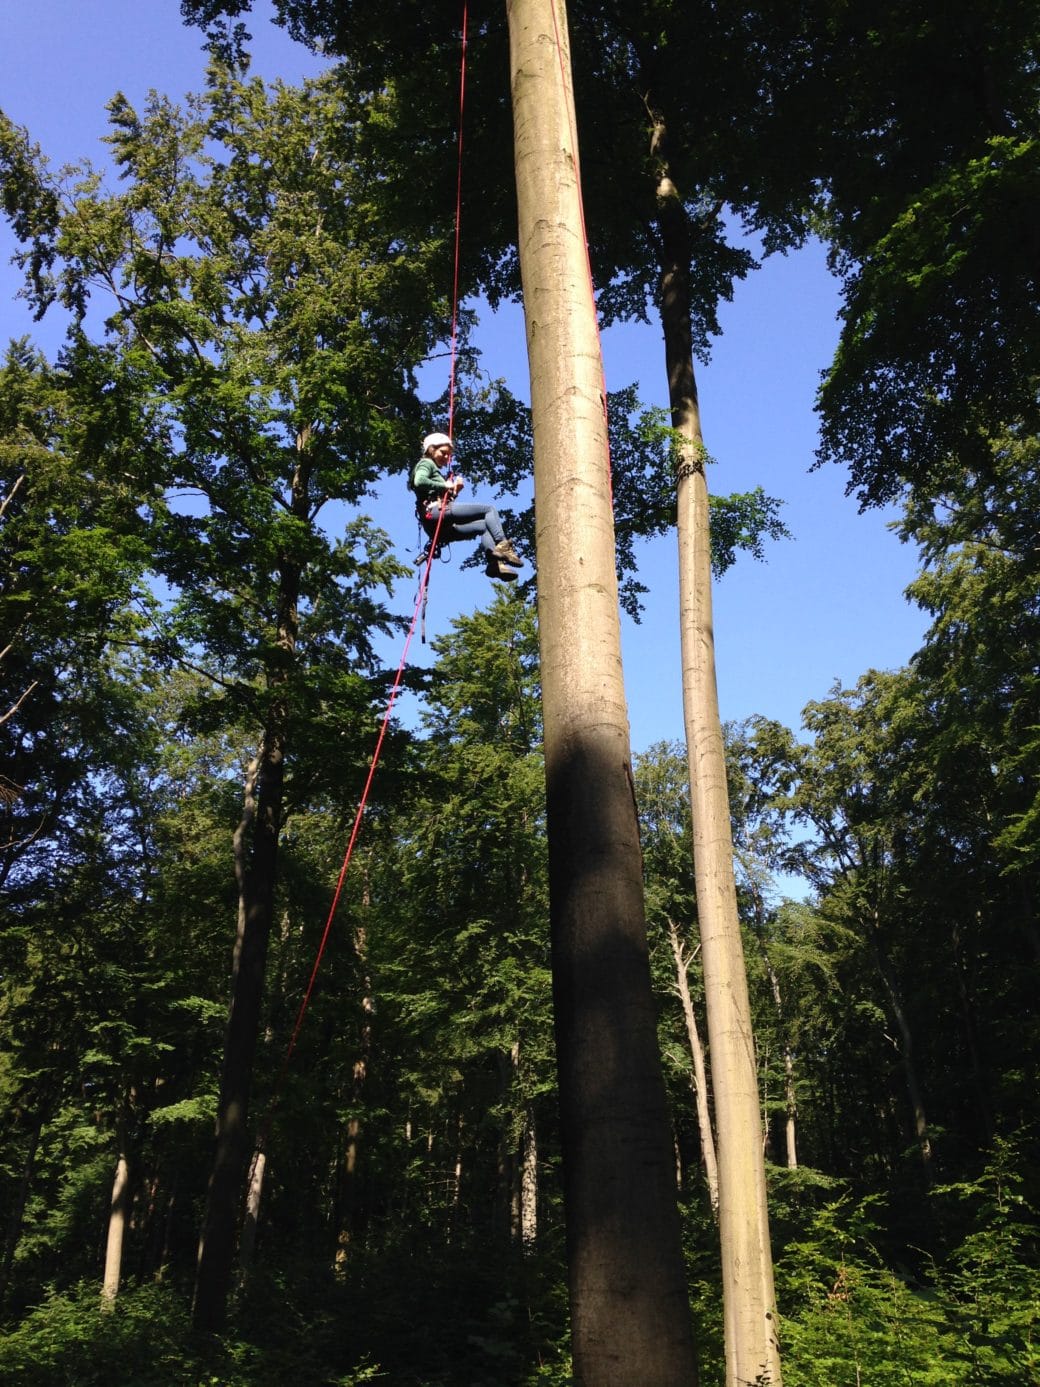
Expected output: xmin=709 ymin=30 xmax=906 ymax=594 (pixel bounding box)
xmin=0 ymin=0 xmax=925 ymax=750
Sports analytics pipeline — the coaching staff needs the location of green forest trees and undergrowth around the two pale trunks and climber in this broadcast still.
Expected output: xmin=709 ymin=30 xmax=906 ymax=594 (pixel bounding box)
xmin=0 ymin=0 xmax=1040 ymax=1387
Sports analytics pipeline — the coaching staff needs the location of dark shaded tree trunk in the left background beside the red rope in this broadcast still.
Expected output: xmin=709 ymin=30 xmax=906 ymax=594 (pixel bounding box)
xmin=193 ymin=443 xmax=311 ymax=1332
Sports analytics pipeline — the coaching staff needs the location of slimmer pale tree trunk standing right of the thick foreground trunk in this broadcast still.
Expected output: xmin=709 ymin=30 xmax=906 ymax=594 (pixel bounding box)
xmin=655 ymin=123 xmax=781 ymax=1387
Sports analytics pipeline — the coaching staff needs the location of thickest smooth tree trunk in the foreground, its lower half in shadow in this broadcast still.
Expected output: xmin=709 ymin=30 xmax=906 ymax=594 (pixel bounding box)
xmin=506 ymin=0 xmax=695 ymax=1387
